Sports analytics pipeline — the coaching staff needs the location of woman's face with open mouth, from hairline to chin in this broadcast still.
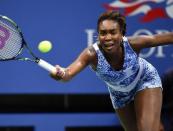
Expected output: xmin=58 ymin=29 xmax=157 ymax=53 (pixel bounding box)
xmin=98 ymin=20 xmax=123 ymax=53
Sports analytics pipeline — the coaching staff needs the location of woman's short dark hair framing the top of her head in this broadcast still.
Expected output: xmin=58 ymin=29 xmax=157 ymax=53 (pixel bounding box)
xmin=97 ymin=11 xmax=126 ymax=36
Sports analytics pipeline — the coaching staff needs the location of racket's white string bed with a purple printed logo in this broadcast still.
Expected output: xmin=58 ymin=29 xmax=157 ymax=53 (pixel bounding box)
xmin=0 ymin=19 xmax=22 ymax=60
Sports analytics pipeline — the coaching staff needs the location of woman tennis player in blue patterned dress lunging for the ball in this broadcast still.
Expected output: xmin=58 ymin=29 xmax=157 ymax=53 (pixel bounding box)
xmin=51 ymin=11 xmax=173 ymax=131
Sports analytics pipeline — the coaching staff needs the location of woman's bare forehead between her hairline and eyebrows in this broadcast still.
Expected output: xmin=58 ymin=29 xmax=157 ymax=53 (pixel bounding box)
xmin=99 ymin=20 xmax=120 ymax=30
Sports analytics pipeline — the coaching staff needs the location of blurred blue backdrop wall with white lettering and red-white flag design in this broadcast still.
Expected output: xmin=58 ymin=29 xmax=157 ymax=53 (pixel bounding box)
xmin=0 ymin=0 xmax=173 ymax=131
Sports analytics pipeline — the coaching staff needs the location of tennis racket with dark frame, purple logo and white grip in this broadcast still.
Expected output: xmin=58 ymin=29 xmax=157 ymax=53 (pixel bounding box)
xmin=0 ymin=15 xmax=63 ymax=73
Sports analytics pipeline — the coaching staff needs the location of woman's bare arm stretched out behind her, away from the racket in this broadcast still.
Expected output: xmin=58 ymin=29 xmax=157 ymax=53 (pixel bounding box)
xmin=128 ymin=32 xmax=173 ymax=53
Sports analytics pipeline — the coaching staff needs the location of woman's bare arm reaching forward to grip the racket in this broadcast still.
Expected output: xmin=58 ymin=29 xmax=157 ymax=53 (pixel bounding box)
xmin=51 ymin=47 xmax=96 ymax=81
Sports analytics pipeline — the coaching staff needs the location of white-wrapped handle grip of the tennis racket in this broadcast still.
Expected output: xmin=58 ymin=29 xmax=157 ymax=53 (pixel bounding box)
xmin=38 ymin=59 xmax=56 ymax=73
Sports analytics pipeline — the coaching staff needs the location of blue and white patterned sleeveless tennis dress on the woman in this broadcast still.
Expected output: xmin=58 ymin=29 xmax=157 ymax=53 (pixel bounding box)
xmin=93 ymin=37 xmax=162 ymax=109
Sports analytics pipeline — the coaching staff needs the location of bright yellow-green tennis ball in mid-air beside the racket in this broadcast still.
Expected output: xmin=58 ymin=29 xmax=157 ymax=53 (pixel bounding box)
xmin=38 ymin=40 xmax=52 ymax=53
